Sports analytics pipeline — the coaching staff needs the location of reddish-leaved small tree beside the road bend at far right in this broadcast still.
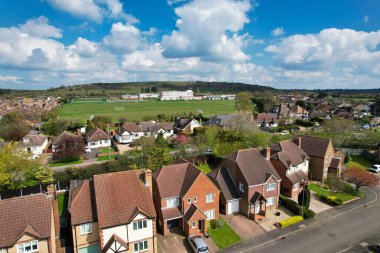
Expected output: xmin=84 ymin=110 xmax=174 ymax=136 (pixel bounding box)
xmin=343 ymin=167 xmax=379 ymax=193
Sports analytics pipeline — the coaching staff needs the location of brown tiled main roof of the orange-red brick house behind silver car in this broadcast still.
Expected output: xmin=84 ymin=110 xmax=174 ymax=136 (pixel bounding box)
xmin=153 ymin=162 xmax=201 ymax=198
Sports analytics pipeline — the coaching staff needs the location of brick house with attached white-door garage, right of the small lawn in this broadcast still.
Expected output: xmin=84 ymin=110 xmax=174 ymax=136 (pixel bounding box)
xmin=209 ymin=148 xmax=281 ymax=219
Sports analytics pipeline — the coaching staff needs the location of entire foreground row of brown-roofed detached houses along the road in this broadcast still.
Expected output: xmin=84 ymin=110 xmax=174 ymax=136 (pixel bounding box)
xmin=0 ymin=136 xmax=344 ymax=253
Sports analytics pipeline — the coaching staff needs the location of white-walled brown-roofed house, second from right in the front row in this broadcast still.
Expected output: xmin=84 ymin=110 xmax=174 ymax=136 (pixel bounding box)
xmin=270 ymin=140 xmax=310 ymax=198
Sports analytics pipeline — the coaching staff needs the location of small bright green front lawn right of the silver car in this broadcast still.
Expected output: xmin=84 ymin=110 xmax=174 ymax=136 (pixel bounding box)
xmin=207 ymin=219 xmax=241 ymax=249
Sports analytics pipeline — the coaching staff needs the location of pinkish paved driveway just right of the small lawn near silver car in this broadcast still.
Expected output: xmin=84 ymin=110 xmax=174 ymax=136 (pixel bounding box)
xmin=220 ymin=214 xmax=265 ymax=240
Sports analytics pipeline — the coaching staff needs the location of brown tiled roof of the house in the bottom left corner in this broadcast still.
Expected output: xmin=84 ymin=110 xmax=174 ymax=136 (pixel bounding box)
xmin=0 ymin=194 xmax=52 ymax=249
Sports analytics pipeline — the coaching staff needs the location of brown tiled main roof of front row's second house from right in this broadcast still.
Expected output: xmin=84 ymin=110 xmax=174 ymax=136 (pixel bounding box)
xmin=271 ymin=140 xmax=310 ymax=168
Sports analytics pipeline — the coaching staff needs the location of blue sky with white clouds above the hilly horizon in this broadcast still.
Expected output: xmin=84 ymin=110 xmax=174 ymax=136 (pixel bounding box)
xmin=0 ymin=0 xmax=380 ymax=89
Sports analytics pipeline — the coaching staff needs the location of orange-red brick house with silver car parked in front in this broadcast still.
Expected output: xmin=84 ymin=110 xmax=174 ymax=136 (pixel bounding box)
xmin=153 ymin=160 xmax=219 ymax=235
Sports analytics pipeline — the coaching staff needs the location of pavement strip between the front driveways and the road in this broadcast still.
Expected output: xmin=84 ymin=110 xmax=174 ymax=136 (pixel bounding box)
xmin=220 ymin=188 xmax=377 ymax=252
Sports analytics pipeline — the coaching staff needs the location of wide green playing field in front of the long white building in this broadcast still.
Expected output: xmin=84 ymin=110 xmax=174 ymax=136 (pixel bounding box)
xmin=59 ymin=99 xmax=235 ymax=122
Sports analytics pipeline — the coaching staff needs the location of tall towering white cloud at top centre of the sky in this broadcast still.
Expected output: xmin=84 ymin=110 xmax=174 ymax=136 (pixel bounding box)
xmin=162 ymin=0 xmax=251 ymax=61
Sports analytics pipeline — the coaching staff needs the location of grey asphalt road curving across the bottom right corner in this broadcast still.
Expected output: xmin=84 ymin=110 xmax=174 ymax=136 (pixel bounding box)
xmin=223 ymin=186 xmax=380 ymax=253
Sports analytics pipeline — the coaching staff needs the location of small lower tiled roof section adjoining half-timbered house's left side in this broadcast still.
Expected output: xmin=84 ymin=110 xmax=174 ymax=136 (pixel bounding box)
xmin=69 ymin=180 xmax=97 ymax=225
